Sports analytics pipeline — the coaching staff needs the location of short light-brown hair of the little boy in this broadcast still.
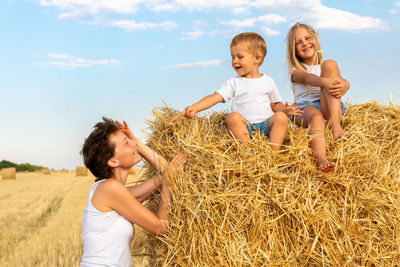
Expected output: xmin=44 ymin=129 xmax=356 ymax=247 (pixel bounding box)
xmin=231 ymin=32 xmax=267 ymax=66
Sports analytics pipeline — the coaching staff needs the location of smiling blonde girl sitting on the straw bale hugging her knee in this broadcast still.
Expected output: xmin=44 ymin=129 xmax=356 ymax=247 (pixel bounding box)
xmin=287 ymin=23 xmax=350 ymax=172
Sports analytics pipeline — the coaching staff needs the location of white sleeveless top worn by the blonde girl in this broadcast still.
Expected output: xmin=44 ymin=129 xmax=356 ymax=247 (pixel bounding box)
xmin=292 ymin=64 xmax=321 ymax=103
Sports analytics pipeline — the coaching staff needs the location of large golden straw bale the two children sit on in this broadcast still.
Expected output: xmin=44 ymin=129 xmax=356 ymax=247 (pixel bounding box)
xmin=146 ymin=103 xmax=400 ymax=266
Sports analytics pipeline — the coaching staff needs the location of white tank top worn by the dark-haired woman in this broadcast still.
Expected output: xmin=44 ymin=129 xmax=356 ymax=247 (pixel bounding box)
xmin=81 ymin=180 xmax=135 ymax=267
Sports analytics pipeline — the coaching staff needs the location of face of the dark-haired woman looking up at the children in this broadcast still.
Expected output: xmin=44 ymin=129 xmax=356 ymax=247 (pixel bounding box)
xmin=110 ymin=131 xmax=142 ymax=168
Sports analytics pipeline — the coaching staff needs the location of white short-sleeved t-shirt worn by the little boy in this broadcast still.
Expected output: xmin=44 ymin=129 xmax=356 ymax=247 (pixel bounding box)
xmin=216 ymin=74 xmax=282 ymax=123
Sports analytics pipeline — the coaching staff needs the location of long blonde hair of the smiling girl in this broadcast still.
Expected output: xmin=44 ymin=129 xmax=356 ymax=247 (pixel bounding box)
xmin=286 ymin=22 xmax=324 ymax=74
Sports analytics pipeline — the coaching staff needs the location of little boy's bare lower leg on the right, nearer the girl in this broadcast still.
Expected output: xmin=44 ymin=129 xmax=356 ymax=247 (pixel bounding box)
xmin=269 ymin=111 xmax=289 ymax=150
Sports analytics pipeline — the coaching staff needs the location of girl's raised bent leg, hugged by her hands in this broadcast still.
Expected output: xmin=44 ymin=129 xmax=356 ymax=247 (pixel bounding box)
xmin=320 ymin=60 xmax=344 ymax=140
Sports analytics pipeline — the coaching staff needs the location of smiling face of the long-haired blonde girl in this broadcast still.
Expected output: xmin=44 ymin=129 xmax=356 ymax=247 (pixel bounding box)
xmin=294 ymin=27 xmax=315 ymax=65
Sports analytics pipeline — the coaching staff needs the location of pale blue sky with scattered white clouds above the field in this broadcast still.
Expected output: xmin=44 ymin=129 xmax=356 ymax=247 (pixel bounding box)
xmin=0 ymin=0 xmax=400 ymax=169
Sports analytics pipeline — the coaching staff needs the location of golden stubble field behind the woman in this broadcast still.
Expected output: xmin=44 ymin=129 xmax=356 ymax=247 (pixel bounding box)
xmin=0 ymin=172 xmax=149 ymax=266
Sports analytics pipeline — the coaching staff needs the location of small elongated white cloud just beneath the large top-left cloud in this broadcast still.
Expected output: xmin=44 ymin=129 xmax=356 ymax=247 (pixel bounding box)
xmin=103 ymin=20 xmax=177 ymax=31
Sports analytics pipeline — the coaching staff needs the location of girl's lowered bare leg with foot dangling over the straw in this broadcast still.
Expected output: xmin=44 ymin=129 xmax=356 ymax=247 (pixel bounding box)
xmin=295 ymin=106 xmax=335 ymax=172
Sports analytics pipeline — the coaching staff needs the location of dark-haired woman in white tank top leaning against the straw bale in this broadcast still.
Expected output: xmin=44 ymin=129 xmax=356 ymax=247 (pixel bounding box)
xmin=81 ymin=118 xmax=187 ymax=266
